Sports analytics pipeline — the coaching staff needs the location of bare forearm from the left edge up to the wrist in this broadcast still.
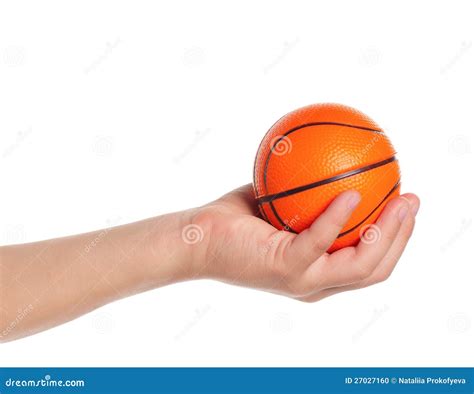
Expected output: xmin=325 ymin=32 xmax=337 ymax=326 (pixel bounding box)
xmin=0 ymin=211 xmax=192 ymax=341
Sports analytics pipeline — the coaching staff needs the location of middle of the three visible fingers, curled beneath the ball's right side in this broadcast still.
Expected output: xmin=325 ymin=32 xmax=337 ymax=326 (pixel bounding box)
xmin=308 ymin=197 xmax=410 ymax=288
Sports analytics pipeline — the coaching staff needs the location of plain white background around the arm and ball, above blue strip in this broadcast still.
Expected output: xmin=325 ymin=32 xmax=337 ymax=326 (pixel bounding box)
xmin=0 ymin=1 xmax=474 ymax=366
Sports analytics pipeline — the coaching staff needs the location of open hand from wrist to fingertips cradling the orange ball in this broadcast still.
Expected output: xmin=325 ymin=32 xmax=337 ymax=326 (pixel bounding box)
xmin=187 ymin=185 xmax=420 ymax=302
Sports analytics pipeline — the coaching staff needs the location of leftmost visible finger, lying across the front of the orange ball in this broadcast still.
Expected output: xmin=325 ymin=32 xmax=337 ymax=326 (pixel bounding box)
xmin=288 ymin=190 xmax=361 ymax=267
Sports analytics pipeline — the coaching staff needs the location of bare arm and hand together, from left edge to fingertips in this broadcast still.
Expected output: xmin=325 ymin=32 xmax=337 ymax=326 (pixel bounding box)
xmin=0 ymin=185 xmax=420 ymax=342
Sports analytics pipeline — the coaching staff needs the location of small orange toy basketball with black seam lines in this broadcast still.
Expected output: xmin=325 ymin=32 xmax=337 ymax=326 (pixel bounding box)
xmin=254 ymin=104 xmax=400 ymax=252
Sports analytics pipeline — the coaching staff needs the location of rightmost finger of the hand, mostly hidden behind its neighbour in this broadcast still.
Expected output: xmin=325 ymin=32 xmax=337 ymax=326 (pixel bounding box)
xmin=302 ymin=194 xmax=420 ymax=302
